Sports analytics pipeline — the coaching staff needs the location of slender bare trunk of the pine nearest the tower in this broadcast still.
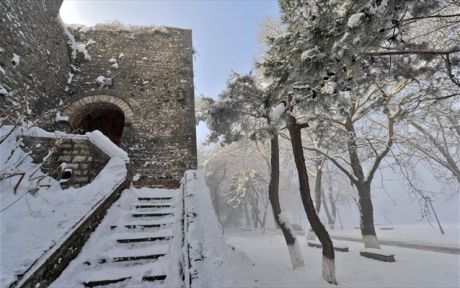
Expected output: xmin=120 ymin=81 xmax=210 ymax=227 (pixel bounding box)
xmin=268 ymin=132 xmax=305 ymax=269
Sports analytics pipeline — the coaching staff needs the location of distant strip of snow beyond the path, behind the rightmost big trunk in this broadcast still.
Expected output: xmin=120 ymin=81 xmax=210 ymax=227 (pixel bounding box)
xmin=331 ymin=223 xmax=460 ymax=247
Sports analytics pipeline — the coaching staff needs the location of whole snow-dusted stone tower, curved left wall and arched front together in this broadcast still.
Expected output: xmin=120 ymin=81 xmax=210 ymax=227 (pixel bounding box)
xmin=0 ymin=0 xmax=197 ymax=187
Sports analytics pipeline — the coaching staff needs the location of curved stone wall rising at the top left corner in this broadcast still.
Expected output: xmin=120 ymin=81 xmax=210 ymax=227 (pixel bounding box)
xmin=0 ymin=0 xmax=70 ymax=122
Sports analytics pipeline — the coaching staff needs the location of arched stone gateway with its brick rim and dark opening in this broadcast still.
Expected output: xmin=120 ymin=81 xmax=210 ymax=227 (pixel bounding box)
xmin=64 ymin=95 xmax=134 ymax=145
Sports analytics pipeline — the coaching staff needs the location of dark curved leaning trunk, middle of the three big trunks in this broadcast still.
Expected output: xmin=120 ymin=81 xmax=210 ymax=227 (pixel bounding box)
xmin=286 ymin=114 xmax=337 ymax=284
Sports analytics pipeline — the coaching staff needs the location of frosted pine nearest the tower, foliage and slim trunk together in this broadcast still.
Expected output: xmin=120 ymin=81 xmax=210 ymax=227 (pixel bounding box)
xmin=198 ymin=74 xmax=304 ymax=268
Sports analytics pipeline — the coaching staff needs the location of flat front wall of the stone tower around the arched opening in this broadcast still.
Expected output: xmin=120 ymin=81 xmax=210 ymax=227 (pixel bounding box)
xmin=67 ymin=26 xmax=197 ymax=187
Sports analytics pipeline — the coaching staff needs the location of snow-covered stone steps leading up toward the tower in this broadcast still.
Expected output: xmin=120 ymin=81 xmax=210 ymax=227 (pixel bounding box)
xmin=50 ymin=188 xmax=180 ymax=287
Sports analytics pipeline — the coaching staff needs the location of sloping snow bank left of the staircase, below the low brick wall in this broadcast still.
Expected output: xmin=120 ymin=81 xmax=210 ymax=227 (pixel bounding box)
xmin=0 ymin=126 xmax=127 ymax=287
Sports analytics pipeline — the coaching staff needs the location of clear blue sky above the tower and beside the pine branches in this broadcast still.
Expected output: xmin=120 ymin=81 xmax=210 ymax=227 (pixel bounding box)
xmin=61 ymin=0 xmax=279 ymax=143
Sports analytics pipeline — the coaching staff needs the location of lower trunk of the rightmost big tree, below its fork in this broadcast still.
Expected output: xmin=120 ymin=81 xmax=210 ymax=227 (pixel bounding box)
xmin=357 ymin=182 xmax=380 ymax=249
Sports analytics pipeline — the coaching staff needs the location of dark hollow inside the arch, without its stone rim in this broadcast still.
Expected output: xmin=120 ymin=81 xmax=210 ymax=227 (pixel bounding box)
xmin=75 ymin=103 xmax=125 ymax=145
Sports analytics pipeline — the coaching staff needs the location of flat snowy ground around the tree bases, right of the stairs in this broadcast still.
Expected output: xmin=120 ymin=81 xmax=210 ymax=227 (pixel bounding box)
xmin=226 ymin=231 xmax=460 ymax=287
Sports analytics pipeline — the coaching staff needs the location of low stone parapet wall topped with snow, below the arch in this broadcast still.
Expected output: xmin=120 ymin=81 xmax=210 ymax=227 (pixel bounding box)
xmin=22 ymin=136 xmax=110 ymax=189
